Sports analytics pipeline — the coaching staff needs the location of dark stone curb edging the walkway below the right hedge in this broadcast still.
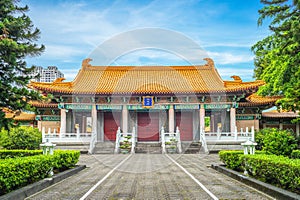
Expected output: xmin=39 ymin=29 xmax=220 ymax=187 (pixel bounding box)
xmin=211 ymin=164 xmax=300 ymax=200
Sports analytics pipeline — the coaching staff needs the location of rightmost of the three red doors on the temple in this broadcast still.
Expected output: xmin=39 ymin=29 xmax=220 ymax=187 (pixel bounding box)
xmin=176 ymin=112 xmax=193 ymax=141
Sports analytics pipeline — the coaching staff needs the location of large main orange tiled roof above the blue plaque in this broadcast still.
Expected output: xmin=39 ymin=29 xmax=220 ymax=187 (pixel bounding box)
xmin=30 ymin=58 xmax=264 ymax=95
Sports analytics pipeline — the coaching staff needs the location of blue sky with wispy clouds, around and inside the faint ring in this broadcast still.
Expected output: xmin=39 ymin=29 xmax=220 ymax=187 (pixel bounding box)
xmin=21 ymin=0 xmax=269 ymax=81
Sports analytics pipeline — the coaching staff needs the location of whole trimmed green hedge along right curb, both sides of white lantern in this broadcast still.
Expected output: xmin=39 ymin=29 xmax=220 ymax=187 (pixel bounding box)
xmin=219 ymin=150 xmax=300 ymax=193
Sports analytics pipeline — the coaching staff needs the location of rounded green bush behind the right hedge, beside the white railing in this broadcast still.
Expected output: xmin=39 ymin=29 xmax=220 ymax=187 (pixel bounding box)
xmin=256 ymin=128 xmax=297 ymax=156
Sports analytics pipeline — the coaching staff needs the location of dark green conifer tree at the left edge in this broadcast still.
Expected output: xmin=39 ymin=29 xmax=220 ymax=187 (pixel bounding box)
xmin=0 ymin=0 xmax=45 ymax=129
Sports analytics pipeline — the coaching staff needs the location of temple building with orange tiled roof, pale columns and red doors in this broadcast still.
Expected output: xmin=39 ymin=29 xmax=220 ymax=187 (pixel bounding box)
xmin=30 ymin=58 xmax=288 ymax=142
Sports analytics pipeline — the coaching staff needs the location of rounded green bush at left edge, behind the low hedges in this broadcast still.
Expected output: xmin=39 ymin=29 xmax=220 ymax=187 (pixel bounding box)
xmin=0 ymin=127 xmax=42 ymax=149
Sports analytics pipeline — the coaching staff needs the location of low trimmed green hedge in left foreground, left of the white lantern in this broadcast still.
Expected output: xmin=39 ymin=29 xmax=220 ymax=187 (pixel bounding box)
xmin=0 ymin=155 xmax=54 ymax=195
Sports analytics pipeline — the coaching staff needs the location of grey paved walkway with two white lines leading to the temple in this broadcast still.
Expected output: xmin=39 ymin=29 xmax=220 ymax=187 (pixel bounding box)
xmin=28 ymin=154 xmax=272 ymax=199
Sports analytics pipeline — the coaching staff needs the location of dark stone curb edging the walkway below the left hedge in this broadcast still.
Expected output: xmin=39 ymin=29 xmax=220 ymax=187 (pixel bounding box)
xmin=0 ymin=165 xmax=86 ymax=200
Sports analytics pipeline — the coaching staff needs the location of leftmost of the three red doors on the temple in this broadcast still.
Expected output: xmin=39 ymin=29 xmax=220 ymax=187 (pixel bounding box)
xmin=104 ymin=112 xmax=121 ymax=141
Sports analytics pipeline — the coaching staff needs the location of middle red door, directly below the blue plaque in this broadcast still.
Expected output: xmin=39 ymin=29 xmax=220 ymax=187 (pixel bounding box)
xmin=138 ymin=112 xmax=159 ymax=141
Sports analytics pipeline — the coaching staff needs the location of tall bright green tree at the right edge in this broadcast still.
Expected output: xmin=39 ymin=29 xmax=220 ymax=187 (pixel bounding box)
xmin=252 ymin=0 xmax=300 ymax=111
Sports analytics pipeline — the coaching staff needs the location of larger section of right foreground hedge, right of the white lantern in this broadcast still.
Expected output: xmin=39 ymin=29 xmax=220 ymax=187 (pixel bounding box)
xmin=241 ymin=154 xmax=300 ymax=193
